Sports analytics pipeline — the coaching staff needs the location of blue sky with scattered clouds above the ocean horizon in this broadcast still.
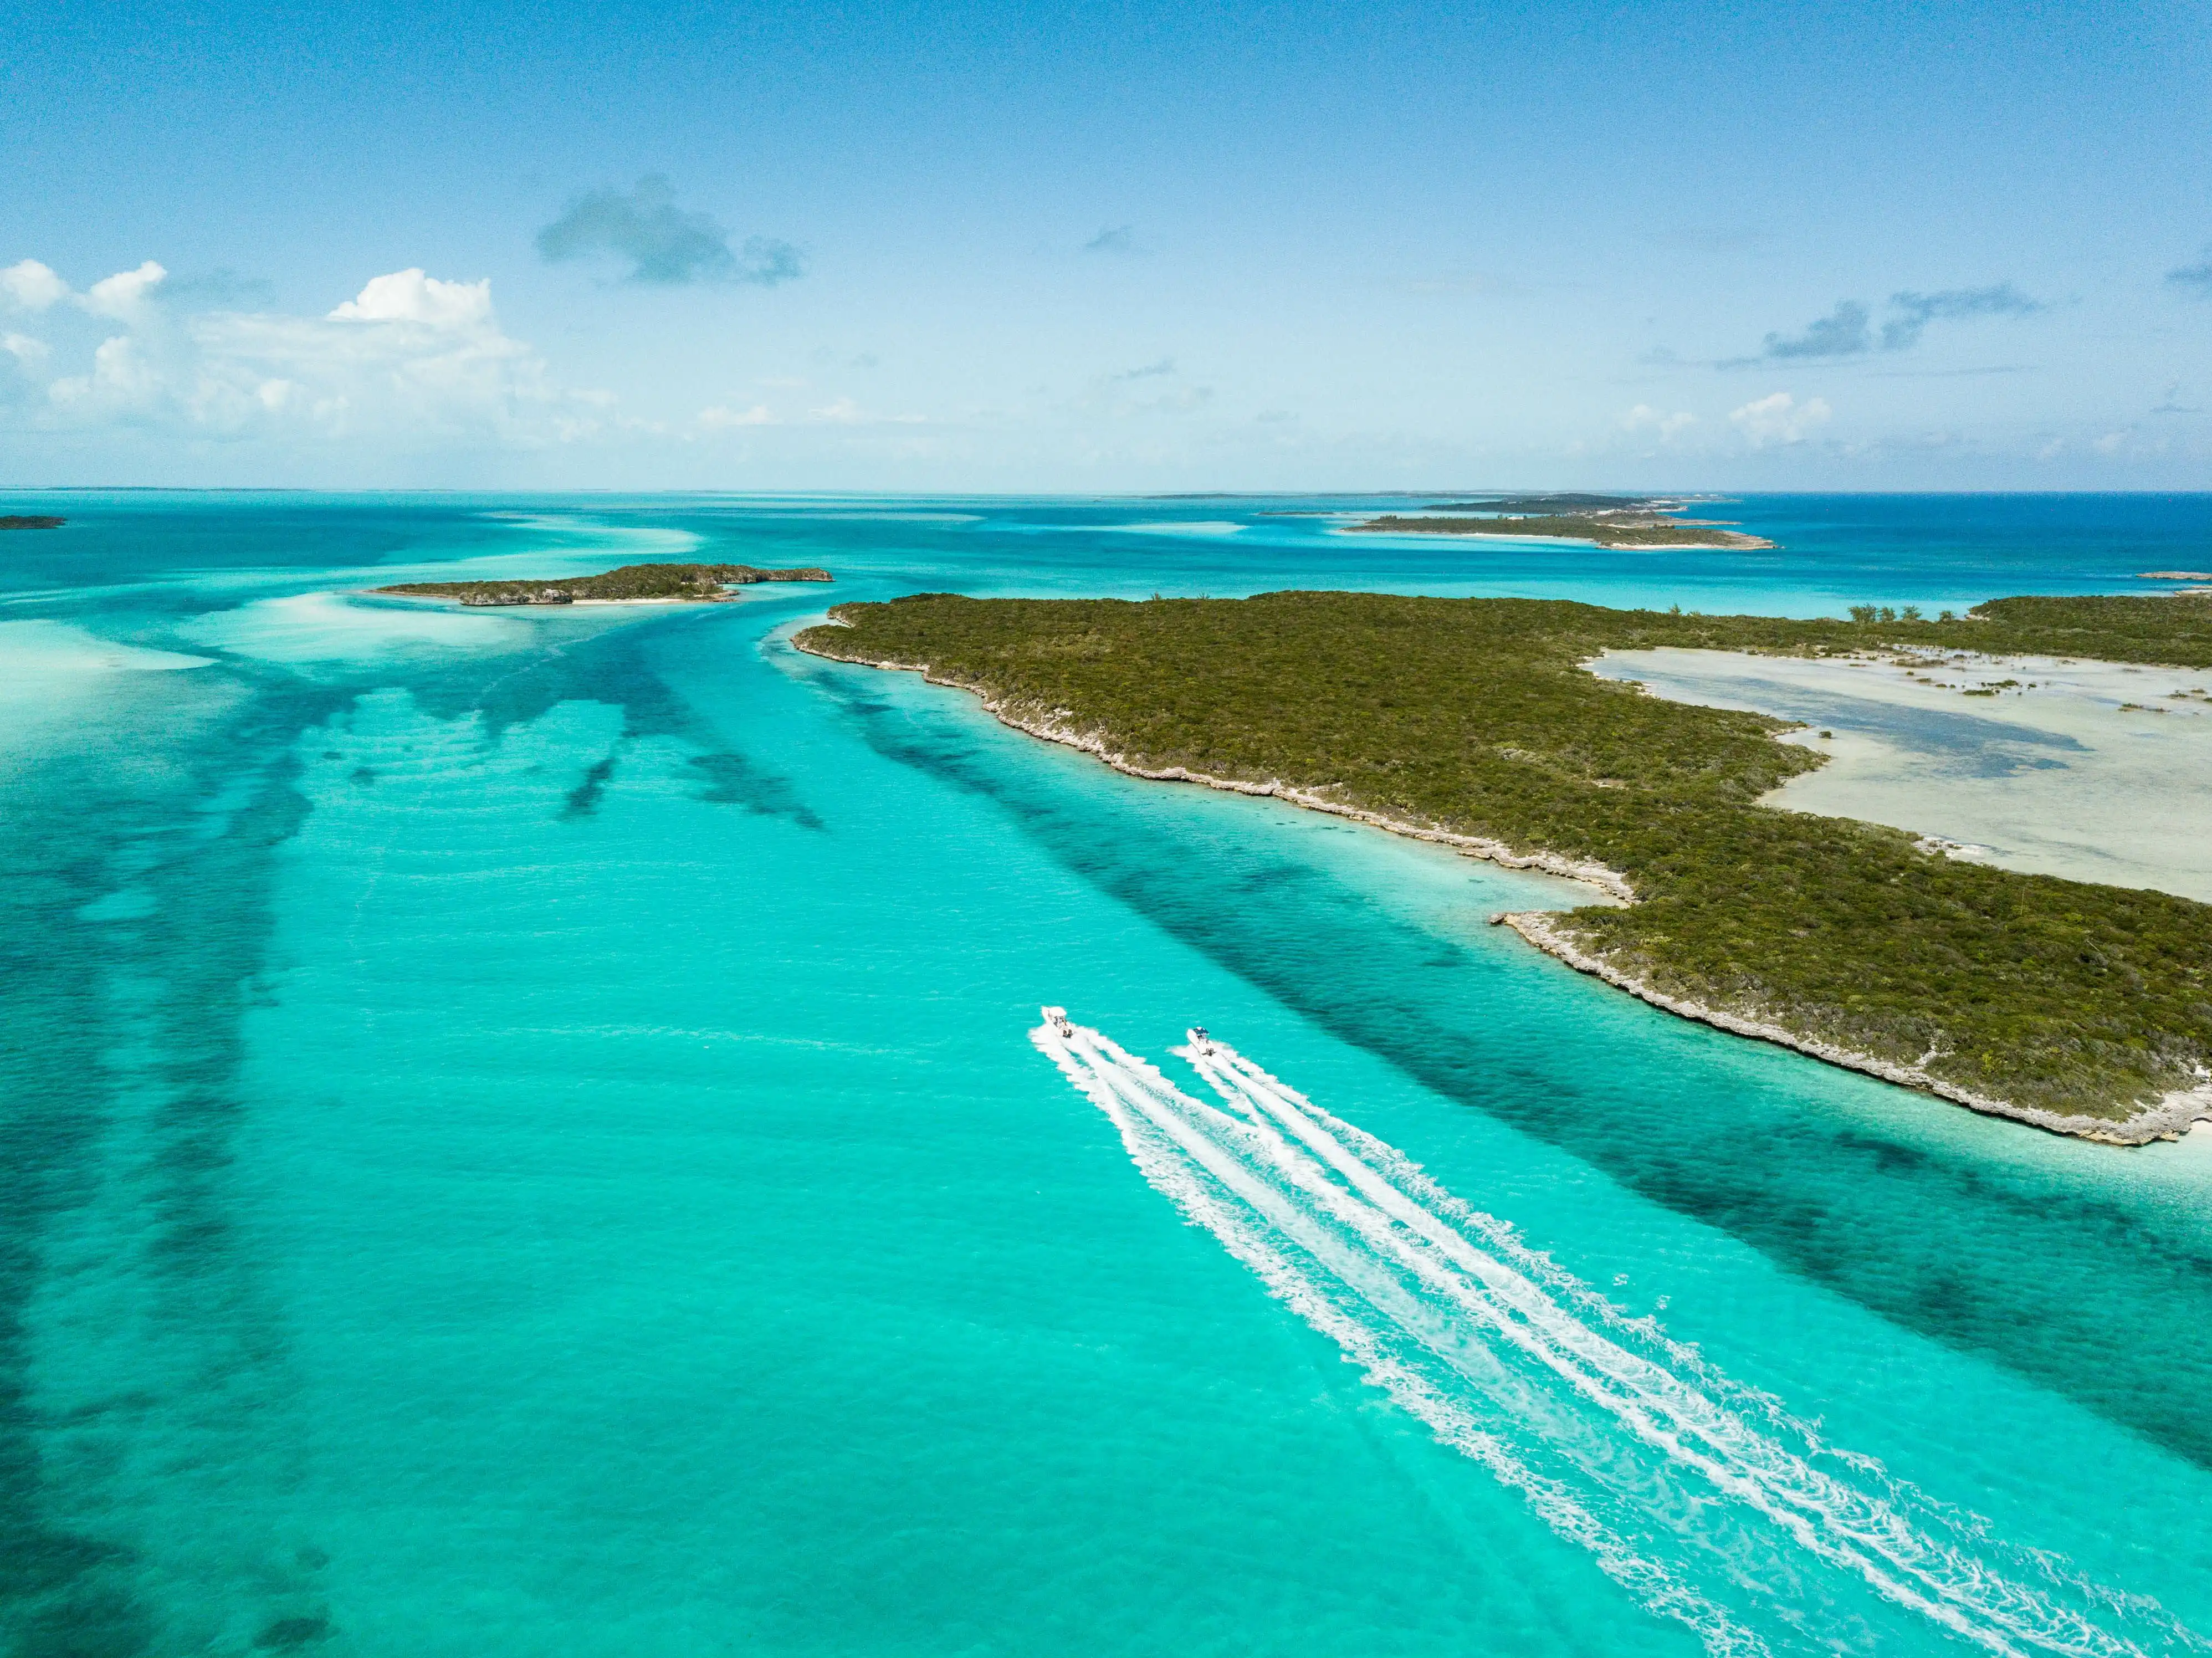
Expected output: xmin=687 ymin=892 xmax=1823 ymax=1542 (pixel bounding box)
xmin=0 ymin=0 xmax=2212 ymax=489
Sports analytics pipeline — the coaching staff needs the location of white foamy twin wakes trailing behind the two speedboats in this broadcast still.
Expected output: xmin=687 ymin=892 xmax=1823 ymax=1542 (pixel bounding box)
xmin=1031 ymin=1007 xmax=2212 ymax=1658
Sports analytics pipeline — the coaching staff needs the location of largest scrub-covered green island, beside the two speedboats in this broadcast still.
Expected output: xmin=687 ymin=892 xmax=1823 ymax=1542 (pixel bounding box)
xmin=796 ymin=593 xmax=2212 ymax=1144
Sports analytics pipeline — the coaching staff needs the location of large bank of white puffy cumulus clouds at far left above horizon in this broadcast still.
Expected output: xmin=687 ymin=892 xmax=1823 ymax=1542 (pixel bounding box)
xmin=4 ymin=259 xmax=575 ymax=445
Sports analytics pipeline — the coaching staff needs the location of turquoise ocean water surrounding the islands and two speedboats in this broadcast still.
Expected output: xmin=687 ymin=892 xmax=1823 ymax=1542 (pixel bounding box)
xmin=0 ymin=494 xmax=2212 ymax=1658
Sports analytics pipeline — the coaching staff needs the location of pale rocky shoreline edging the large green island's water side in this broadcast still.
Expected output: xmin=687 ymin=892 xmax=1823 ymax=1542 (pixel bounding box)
xmin=792 ymin=618 xmax=2212 ymax=1147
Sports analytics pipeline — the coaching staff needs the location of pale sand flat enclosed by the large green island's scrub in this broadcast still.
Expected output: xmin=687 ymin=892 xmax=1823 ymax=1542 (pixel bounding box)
xmin=1590 ymin=648 xmax=2212 ymax=903
